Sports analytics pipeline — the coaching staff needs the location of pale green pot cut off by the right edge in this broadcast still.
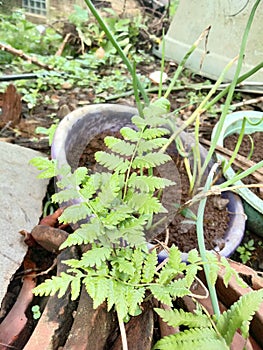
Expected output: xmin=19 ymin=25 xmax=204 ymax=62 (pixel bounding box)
xmin=212 ymin=111 xmax=263 ymax=236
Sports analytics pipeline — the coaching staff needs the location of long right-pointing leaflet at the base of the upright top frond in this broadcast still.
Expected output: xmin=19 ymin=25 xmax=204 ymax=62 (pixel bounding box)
xmin=128 ymin=173 xmax=175 ymax=192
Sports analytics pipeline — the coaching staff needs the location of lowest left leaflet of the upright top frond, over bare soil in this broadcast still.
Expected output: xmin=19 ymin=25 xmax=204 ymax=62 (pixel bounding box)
xmin=95 ymin=151 xmax=129 ymax=173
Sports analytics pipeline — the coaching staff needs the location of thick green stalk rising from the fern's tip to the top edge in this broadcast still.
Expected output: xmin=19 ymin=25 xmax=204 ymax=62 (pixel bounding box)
xmin=84 ymin=0 xmax=149 ymax=104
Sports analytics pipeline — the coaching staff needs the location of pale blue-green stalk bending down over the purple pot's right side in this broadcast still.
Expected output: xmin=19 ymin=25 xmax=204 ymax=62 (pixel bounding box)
xmin=196 ymin=163 xmax=220 ymax=319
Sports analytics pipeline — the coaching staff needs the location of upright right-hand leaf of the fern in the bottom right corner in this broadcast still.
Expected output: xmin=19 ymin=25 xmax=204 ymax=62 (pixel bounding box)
xmin=217 ymin=289 xmax=263 ymax=345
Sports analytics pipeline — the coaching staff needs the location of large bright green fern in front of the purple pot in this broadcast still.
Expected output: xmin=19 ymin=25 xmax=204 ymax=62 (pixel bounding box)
xmin=32 ymin=101 xmax=200 ymax=321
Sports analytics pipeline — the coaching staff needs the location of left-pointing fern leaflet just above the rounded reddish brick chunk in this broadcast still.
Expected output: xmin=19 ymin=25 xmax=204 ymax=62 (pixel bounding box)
xmin=59 ymin=202 xmax=92 ymax=224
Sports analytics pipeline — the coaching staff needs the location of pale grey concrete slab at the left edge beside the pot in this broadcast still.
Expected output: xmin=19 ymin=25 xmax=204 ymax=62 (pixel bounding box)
xmin=0 ymin=142 xmax=48 ymax=305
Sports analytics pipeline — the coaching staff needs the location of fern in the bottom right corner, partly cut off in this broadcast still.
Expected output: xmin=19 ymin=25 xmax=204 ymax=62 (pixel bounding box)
xmin=154 ymin=289 xmax=263 ymax=350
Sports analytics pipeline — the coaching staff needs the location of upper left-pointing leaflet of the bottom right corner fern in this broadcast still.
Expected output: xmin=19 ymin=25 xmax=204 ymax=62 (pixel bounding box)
xmin=154 ymin=309 xmax=211 ymax=328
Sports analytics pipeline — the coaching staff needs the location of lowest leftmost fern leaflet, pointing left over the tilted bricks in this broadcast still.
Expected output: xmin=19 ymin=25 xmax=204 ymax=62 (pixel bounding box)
xmin=33 ymin=272 xmax=75 ymax=298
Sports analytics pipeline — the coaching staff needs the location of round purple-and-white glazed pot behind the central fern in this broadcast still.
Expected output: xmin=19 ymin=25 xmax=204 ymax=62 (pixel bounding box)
xmin=51 ymin=104 xmax=248 ymax=260
